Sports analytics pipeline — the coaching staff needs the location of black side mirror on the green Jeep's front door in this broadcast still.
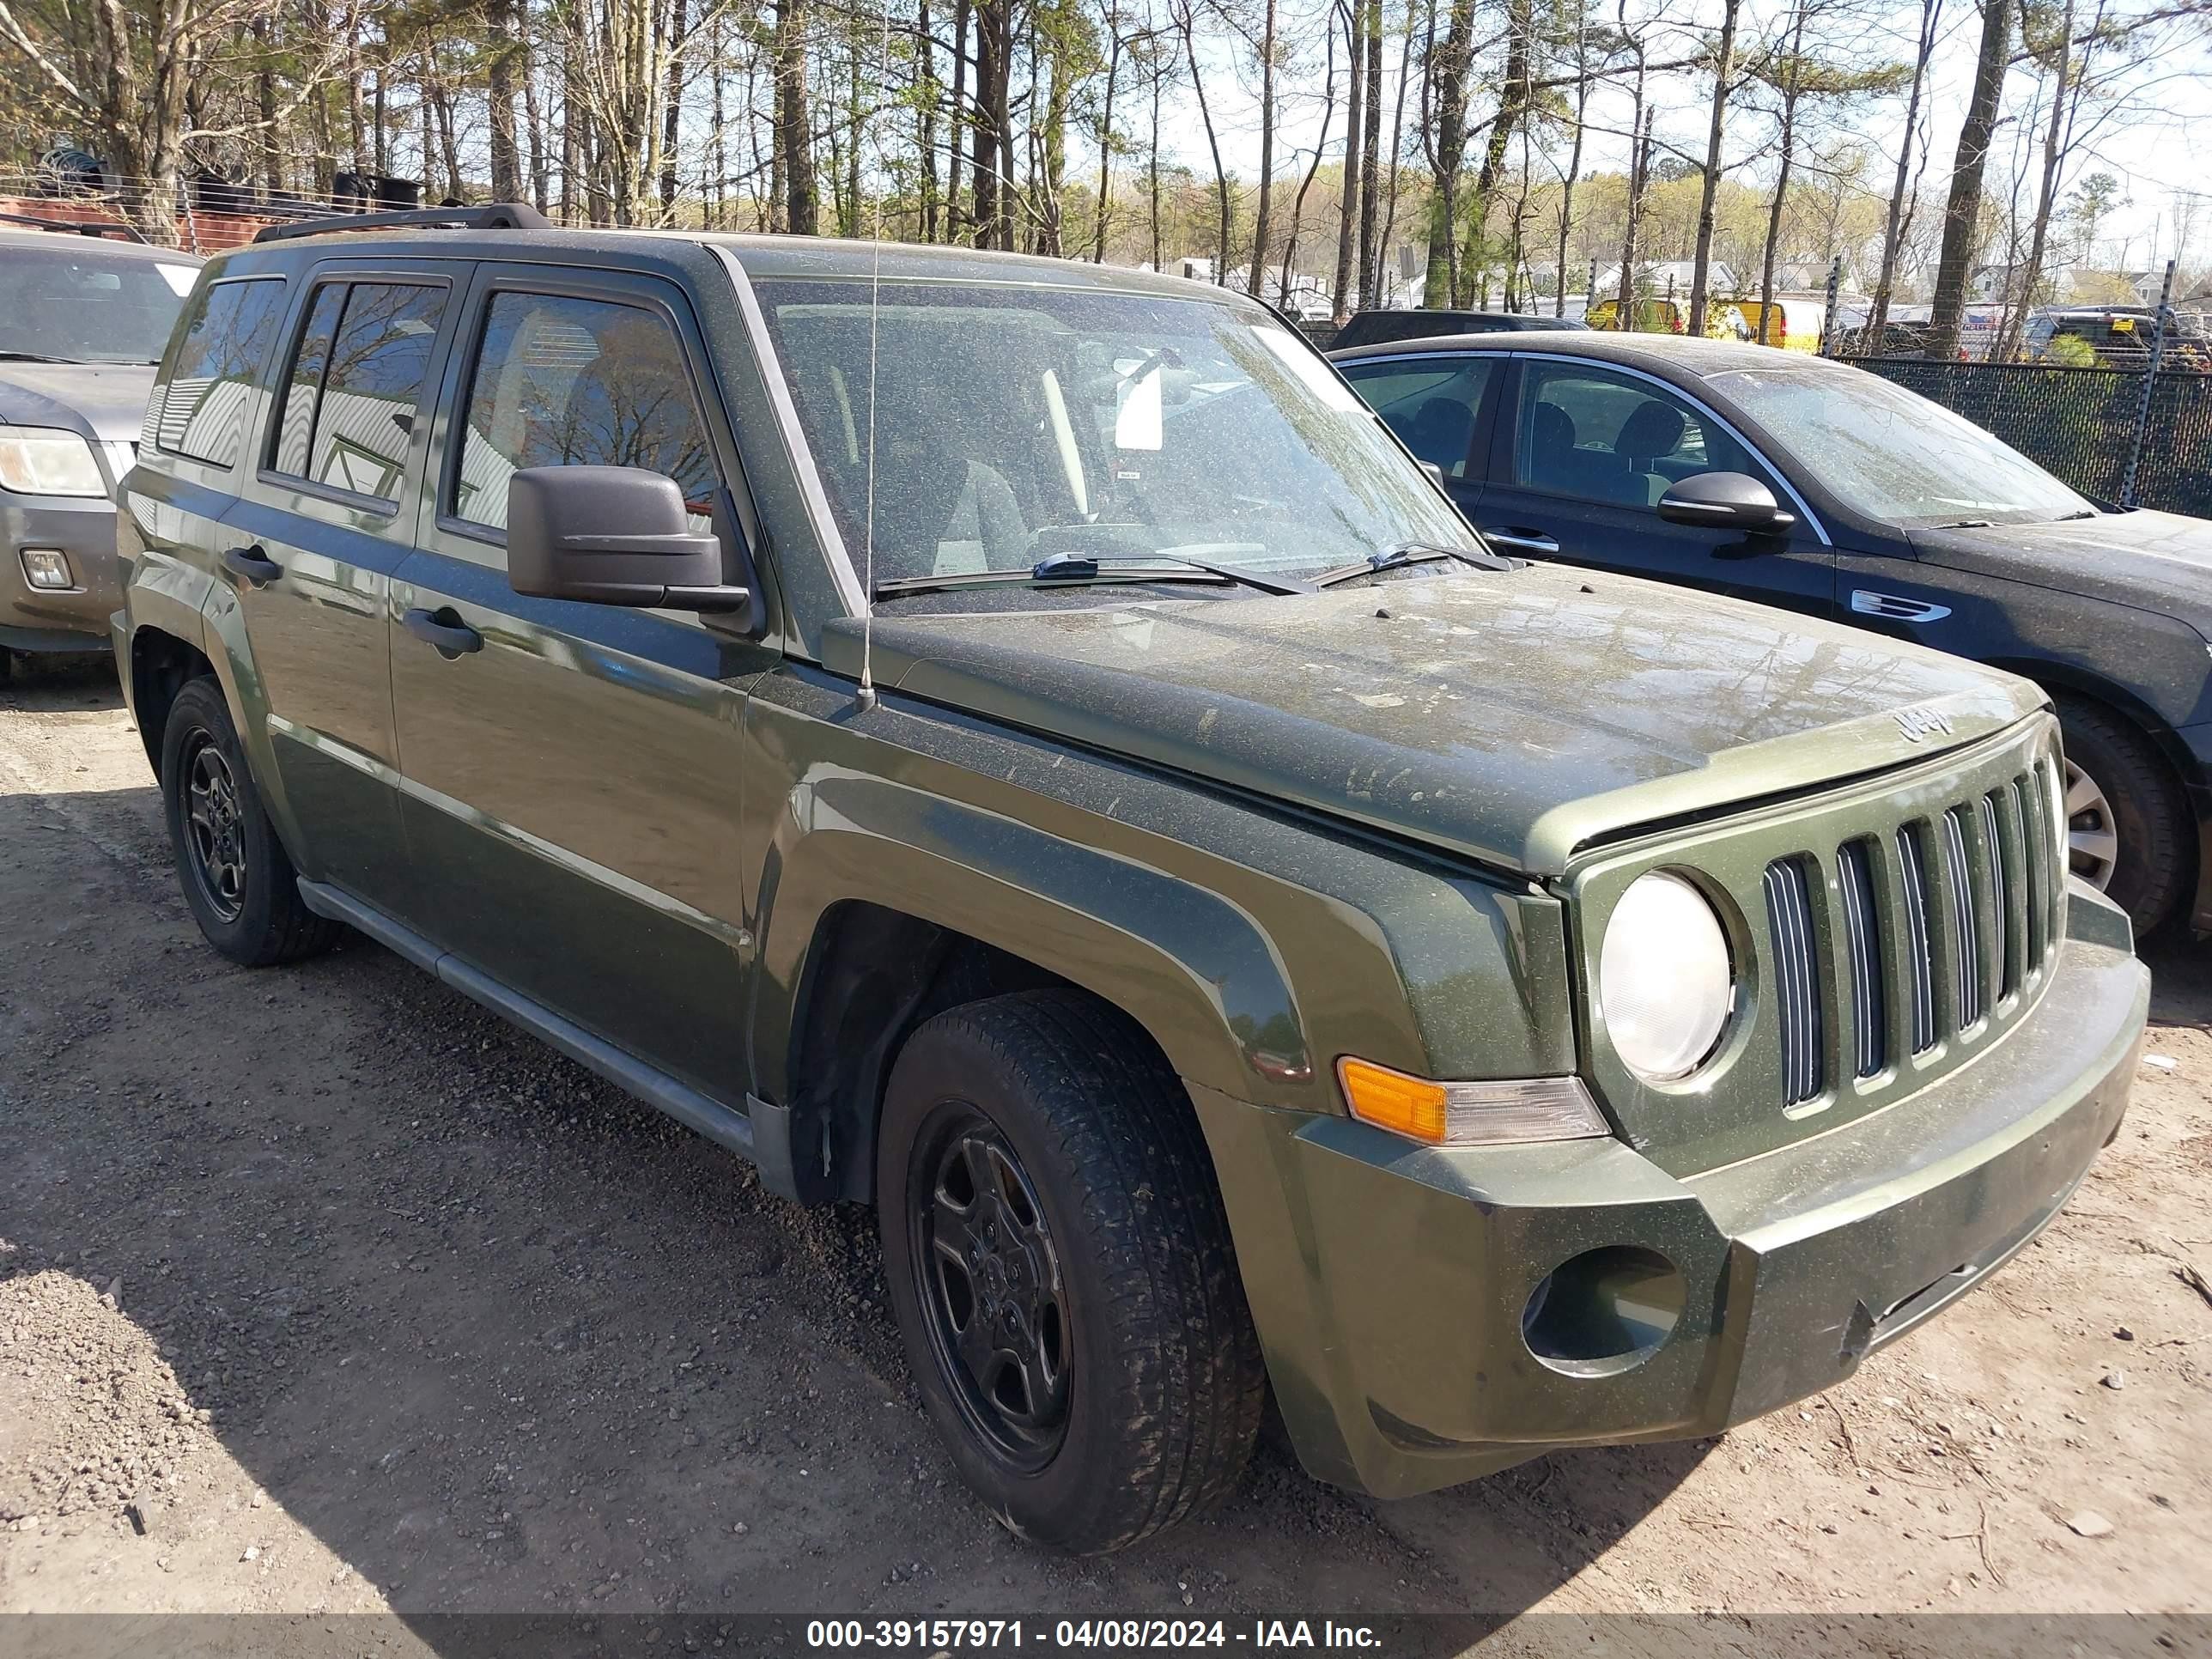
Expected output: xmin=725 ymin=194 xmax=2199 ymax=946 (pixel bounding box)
xmin=507 ymin=467 xmax=754 ymax=611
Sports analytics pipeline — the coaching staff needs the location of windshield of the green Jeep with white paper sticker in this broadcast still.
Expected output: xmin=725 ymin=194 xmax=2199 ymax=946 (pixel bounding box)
xmin=757 ymin=279 xmax=1474 ymax=586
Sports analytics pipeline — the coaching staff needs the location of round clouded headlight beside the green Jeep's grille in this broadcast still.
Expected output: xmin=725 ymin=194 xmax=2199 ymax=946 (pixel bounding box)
xmin=1597 ymin=872 xmax=1736 ymax=1082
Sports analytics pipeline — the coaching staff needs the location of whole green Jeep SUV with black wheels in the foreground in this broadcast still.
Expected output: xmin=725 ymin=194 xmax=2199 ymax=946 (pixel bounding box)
xmin=115 ymin=208 xmax=2148 ymax=1551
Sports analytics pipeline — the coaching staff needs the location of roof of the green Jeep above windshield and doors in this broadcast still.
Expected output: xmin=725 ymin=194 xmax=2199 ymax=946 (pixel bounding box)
xmin=216 ymin=226 xmax=1249 ymax=303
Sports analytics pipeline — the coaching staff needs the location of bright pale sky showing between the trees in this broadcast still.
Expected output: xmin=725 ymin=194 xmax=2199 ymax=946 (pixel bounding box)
xmin=1141 ymin=0 xmax=2212 ymax=270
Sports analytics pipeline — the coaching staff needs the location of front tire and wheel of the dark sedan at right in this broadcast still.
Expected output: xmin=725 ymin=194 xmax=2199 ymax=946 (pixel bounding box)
xmin=2059 ymin=699 xmax=2197 ymax=938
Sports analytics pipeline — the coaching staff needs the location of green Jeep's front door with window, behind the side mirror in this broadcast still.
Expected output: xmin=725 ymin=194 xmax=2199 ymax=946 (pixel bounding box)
xmin=392 ymin=265 xmax=772 ymax=1106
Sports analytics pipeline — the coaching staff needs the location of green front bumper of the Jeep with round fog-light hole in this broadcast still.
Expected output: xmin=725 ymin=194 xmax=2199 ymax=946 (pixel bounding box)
xmin=1192 ymin=890 xmax=2150 ymax=1498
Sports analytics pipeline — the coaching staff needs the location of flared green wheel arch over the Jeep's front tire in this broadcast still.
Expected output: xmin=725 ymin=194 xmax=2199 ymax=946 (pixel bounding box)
xmin=754 ymin=779 xmax=1328 ymax=1199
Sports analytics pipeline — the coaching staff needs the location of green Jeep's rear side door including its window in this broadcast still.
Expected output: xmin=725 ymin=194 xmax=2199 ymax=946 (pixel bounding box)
xmin=219 ymin=258 xmax=456 ymax=902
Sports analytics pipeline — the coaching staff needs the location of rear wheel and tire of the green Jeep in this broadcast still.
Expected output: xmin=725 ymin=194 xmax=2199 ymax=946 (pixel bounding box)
xmin=161 ymin=677 xmax=341 ymax=967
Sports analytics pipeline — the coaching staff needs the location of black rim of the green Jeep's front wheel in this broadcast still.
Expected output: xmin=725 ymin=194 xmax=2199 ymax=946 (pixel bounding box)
xmin=907 ymin=1103 xmax=1073 ymax=1471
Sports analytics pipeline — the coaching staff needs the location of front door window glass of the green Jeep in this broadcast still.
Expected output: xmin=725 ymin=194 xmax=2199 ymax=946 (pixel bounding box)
xmin=445 ymin=292 xmax=721 ymax=529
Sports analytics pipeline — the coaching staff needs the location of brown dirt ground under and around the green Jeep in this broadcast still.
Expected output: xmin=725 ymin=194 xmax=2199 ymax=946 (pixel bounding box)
xmin=0 ymin=668 xmax=2212 ymax=1652
